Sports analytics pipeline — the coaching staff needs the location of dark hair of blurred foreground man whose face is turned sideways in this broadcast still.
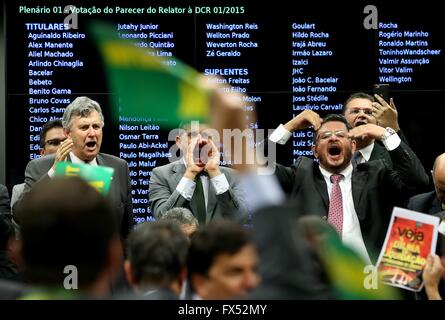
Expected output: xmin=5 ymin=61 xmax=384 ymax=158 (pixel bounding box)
xmin=187 ymin=219 xmax=252 ymax=279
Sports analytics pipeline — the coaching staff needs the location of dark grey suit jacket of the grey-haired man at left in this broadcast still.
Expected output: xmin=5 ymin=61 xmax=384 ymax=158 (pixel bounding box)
xmin=14 ymin=153 xmax=133 ymax=239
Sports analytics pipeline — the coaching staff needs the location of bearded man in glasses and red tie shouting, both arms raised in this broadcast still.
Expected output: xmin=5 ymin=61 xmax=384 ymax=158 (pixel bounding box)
xmin=270 ymin=110 xmax=428 ymax=261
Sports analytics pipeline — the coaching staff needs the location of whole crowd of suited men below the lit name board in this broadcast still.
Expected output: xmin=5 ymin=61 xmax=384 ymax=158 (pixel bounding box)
xmin=0 ymin=92 xmax=445 ymax=300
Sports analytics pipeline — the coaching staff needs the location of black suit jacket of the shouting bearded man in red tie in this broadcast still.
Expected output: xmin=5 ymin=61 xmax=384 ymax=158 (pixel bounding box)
xmin=275 ymin=142 xmax=428 ymax=259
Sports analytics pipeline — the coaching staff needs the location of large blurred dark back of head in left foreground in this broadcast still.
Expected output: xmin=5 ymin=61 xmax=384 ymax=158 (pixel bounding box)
xmin=16 ymin=177 xmax=118 ymax=286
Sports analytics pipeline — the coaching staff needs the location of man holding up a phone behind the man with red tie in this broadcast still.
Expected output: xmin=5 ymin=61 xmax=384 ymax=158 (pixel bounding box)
xmin=343 ymin=92 xmax=408 ymax=167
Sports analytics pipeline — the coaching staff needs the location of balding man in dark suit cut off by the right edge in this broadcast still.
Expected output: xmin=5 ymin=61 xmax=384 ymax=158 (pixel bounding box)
xmin=408 ymin=153 xmax=445 ymax=218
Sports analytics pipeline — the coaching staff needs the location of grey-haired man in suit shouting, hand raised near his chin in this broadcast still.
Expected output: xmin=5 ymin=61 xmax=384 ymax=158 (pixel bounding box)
xmin=14 ymin=97 xmax=133 ymax=239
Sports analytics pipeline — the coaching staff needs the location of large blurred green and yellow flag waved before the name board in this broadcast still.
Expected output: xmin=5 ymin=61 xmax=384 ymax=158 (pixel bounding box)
xmin=89 ymin=22 xmax=210 ymax=128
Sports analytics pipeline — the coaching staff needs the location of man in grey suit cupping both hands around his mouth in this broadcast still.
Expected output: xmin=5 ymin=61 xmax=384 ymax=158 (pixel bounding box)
xmin=149 ymin=121 xmax=247 ymax=224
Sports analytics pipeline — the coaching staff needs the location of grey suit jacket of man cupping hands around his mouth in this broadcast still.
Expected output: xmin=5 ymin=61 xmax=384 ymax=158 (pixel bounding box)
xmin=149 ymin=160 xmax=247 ymax=222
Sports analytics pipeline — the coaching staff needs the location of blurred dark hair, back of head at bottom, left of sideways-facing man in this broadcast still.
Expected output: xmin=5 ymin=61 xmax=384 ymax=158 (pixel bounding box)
xmin=127 ymin=221 xmax=189 ymax=287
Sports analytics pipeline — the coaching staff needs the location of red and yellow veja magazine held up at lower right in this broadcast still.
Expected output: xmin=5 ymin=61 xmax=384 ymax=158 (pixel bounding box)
xmin=377 ymin=207 xmax=440 ymax=292
